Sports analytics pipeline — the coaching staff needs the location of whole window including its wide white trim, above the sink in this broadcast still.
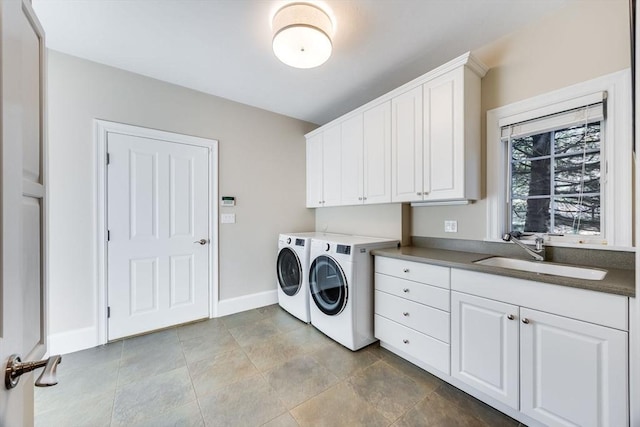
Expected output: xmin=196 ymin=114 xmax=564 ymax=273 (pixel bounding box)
xmin=487 ymin=70 xmax=633 ymax=247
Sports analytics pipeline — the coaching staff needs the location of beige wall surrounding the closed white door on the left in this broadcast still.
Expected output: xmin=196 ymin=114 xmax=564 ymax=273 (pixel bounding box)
xmin=48 ymin=52 xmax=315 ymax=342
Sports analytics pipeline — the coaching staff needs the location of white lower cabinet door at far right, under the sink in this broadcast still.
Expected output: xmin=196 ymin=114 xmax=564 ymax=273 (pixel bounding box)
xmin=520 ymin=308 xmax=628 ymax=427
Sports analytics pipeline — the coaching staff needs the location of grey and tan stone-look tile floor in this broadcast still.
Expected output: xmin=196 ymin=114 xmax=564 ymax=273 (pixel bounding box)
xmin=35 ymin=305 xmax=520 ymax=427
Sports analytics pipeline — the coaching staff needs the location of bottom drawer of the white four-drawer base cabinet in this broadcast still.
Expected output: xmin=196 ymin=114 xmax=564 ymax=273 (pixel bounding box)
xmin=374 ymin=314 xmax=450 ymax=375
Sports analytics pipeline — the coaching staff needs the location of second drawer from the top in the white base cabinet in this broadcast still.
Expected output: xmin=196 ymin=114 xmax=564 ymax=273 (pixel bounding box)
xmin=375 ymin=273 xmax=450 ymax=311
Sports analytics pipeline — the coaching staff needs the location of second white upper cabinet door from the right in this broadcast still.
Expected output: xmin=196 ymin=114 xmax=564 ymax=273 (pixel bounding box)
xmin=391 ymin=87 xmax=423 ymax=202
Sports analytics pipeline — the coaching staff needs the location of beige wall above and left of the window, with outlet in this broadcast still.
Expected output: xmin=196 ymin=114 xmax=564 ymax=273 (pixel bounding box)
xmin=411 ymin=0 xmax=631 ymax=240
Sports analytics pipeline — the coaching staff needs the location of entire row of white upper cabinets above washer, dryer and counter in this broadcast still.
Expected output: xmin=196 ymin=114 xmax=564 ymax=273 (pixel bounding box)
xmin=306 ymin=53 xmax=487 ymax=207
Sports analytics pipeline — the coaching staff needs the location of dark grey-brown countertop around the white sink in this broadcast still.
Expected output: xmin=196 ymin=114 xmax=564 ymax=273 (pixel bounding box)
xmin=371 ymin=246 xmax=636 ymax=297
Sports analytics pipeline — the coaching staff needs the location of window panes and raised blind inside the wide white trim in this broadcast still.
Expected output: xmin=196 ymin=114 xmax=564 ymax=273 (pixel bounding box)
xmin=501 ymin=103 xmax=604 ymax=236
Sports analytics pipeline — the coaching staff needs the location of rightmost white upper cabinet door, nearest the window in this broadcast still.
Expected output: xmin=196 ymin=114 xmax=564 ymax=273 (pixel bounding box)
xmin=423 ymin=68 xmax=464 ymax=200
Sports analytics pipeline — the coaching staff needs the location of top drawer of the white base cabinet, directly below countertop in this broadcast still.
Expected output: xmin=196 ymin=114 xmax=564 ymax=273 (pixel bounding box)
xmin=375 ymin=256 xmax=450 ymax=289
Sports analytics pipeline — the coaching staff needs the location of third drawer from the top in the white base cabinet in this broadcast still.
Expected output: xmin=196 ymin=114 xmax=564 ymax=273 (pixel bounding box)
xmin=375 ymin=291 xmax=451 ymax=343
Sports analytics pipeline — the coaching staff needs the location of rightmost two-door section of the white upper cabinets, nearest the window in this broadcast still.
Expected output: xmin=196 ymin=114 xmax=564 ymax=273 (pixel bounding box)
xmin=392 ymin=59 xmax=481 ymax=202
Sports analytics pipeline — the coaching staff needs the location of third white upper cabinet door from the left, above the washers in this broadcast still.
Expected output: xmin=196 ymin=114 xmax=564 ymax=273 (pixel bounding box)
xmin=340 ymin=114 xmax=364 ymax=205
